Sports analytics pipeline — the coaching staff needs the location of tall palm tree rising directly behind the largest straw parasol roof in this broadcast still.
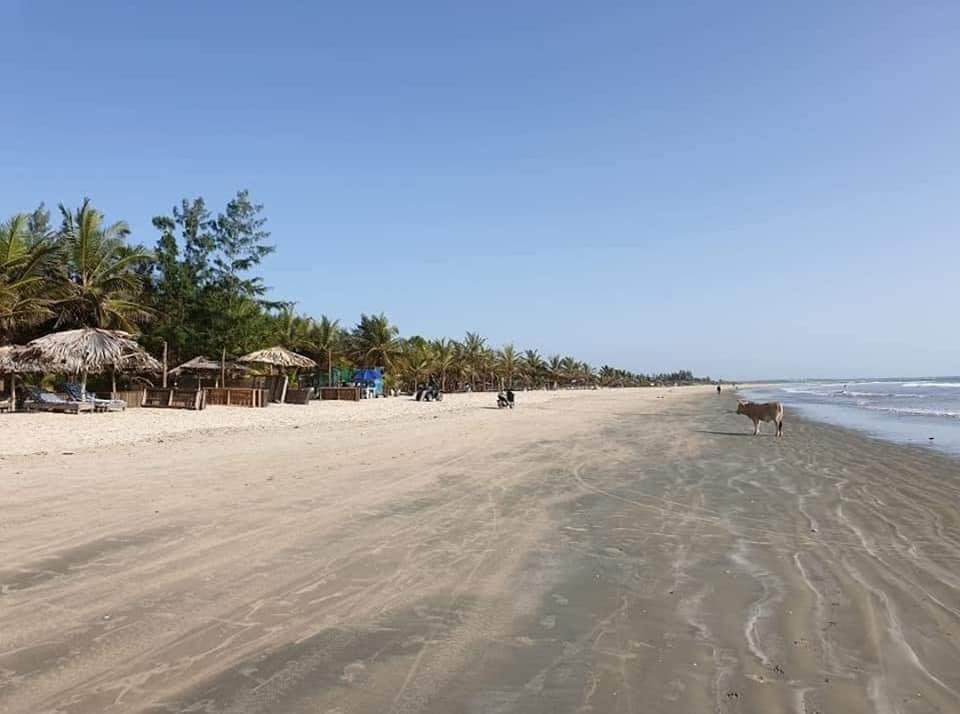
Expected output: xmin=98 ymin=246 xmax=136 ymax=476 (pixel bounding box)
xmin=56 ymin=199 xmax=149 ymax=330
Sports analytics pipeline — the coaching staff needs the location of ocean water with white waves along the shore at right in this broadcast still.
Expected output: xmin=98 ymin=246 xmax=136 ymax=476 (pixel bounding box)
xmin=740 ymin=377 xmax=960 ymax=454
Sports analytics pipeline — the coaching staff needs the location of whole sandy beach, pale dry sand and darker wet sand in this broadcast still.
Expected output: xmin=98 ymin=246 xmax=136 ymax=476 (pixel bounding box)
xmin=0 ymin=390 xmax=960 ymax=714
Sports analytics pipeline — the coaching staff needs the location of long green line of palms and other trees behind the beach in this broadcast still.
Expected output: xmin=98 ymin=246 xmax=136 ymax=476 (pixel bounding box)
xmin=0 ymin=191 xmax=709 ymax=391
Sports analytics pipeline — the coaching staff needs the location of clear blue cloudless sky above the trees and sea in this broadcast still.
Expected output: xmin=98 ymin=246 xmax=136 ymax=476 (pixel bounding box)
xmin=0 ymin=0 xmax=960 ymax=379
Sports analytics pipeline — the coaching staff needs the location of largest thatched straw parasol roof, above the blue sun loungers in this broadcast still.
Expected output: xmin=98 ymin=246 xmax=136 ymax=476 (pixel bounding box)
xmin=15 ymin=327 xmax=156 ymax=374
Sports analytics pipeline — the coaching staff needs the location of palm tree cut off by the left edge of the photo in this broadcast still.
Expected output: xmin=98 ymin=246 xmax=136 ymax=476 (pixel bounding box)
xmin=0 ymin=214 xmax=53 ymax=335
